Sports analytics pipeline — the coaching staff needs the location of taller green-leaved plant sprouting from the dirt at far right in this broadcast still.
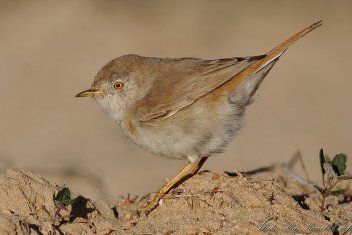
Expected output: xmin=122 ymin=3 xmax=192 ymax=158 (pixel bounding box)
xmin=314 ymin=149 xmax=352 ymax=211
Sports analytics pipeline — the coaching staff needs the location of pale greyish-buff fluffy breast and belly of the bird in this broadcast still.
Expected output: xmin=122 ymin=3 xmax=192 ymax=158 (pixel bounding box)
xmin=120 ymin=93 xmax=242 ymax=159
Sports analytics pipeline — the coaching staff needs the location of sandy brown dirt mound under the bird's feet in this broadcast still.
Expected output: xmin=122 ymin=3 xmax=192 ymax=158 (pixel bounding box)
xmin=0 ymin=170 xmax=352 ymax=234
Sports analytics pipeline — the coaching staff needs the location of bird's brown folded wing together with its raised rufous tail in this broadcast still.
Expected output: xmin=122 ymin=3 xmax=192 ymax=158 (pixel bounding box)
xmin=136 ymin=21 xmax=322 ymax=122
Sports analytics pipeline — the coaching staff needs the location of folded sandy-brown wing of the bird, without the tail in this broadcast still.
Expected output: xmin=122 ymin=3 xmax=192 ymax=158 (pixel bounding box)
xmin=136 ymin=55 xmax=266 ymax=122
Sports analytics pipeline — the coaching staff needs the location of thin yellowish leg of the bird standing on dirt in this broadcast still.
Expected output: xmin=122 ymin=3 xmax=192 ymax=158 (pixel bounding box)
xmin=138 ymin=157 xmax=208 ymax=214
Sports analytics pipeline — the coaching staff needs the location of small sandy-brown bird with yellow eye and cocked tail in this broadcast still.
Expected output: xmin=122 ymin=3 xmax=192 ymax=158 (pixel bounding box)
xmin=76 ymin=21 xmax=322 ymax=214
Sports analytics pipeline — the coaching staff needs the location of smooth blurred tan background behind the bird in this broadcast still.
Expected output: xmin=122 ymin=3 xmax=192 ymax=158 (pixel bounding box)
xmin=0 ymin=0 xmax=352 ymax=200
